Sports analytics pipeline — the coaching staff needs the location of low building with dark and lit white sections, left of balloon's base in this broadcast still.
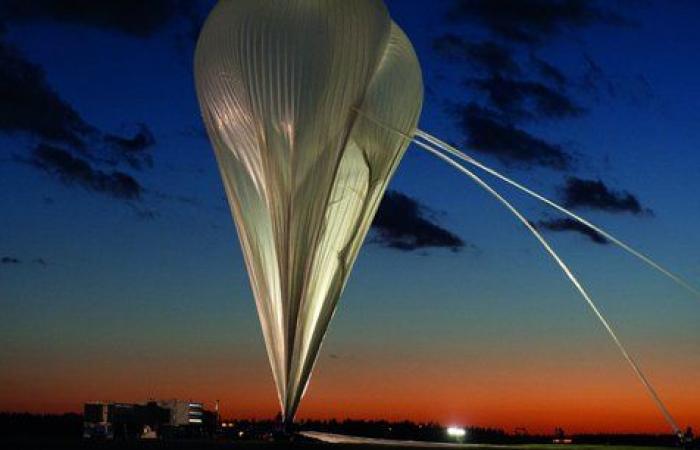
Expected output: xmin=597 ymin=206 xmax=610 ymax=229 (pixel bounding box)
xmin=83 ymin=400 xmax=216 ymax=439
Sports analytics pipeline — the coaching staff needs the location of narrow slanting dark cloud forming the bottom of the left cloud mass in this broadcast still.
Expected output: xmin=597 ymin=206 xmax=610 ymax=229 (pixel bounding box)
xmin=27 ymin=144 xmax=143 ymax=200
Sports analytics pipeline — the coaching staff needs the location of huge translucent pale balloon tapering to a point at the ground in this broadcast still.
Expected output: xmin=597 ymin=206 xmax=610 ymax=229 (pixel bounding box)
xmin=195 ymin=0 xmax=423 ymax=421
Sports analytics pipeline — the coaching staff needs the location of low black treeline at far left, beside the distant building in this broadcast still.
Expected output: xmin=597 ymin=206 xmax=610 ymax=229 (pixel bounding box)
xmin=0 ymin=413 xmax=83 ymax=437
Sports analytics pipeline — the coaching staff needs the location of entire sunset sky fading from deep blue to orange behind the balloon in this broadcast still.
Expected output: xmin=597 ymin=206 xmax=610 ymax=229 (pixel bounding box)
xmin=0 ymin=0 xmax=700 ymax=432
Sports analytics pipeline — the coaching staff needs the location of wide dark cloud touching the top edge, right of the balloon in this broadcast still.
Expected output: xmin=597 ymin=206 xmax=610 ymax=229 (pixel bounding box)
xmin=447 ymin=0 xmax=627 ymax=45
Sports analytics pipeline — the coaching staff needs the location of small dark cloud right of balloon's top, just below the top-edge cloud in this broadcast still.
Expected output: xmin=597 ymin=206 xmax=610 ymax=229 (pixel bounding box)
xmin=433 ymin=33 xmax=520 ymax=74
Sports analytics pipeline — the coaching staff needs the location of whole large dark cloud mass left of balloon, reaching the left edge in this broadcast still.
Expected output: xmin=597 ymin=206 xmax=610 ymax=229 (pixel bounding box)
xmin=0 ymin=36 xmax=155 ymax=200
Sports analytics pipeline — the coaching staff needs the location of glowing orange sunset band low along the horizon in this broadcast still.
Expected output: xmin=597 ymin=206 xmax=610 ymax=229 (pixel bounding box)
xmin=0 ymin=352 xmax=700 ymax=433
